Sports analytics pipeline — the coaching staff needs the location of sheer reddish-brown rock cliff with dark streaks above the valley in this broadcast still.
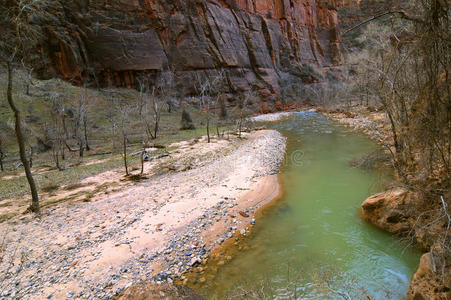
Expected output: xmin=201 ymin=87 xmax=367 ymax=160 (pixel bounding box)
xmin=35 ymin=0 xmax=341 ymax=104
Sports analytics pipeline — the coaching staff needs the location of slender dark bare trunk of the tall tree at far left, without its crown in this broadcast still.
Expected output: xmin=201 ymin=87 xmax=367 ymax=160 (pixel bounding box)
xmin=6 ymin=62 xmax=39 ymax=213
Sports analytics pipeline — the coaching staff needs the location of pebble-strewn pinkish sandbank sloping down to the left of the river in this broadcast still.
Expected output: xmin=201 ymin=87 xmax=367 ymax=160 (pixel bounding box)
xmin=0 ymin=130 xmax=285 ymax=299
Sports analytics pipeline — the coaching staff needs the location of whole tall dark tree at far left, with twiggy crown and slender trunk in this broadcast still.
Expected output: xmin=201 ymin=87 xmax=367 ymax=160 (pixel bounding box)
xmin=0 ymin=0 xmax=56 ymax=212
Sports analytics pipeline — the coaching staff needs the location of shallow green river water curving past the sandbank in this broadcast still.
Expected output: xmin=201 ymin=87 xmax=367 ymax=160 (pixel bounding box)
xmin=195 ymin=112 xmax=419 ymax=299
